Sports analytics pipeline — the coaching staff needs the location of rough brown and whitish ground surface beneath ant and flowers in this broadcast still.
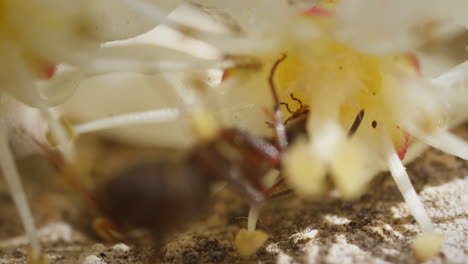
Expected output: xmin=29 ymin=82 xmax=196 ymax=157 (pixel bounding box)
xmin=0 ymin=125 xmax=468 ymax=264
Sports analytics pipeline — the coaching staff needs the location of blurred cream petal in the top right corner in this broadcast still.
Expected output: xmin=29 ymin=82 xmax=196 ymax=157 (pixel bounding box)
xmin=336 ymin=0 xmax=468 ymax=54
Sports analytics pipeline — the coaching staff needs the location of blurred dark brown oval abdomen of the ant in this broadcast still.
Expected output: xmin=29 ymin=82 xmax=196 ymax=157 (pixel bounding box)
xmin=97 ymin=162 xmax=210 ymax=234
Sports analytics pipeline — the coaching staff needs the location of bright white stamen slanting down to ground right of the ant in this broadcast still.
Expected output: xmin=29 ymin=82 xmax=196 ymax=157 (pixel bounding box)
xmin=382 ymin=129 xmax=434 ymax=232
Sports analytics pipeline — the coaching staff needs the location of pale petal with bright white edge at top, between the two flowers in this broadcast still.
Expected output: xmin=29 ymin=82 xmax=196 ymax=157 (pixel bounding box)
xmin=108 ymin=2 xmax=274 ymax=58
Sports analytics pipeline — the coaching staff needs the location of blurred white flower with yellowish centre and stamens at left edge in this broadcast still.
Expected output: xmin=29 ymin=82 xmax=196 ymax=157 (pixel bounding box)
xmin=0 ymin=0 xmax=187 ymax=261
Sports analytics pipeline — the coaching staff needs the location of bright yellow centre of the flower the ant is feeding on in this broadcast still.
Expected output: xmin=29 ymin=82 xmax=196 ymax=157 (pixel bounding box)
xmin=266 ymin=9 xmax=418 ymax=157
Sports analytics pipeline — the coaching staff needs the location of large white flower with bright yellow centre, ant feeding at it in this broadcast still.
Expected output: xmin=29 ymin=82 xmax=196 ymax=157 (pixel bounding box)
xmin=64 ymin=0 xmax=468 ymax=252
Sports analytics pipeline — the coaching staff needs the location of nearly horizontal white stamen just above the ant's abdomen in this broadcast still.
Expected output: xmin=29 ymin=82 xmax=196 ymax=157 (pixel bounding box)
xmin=74 ymin=108 xmax=182 ymax=134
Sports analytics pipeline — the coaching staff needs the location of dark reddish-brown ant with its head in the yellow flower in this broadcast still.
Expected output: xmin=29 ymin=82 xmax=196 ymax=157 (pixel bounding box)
xmin=88 ymin=54 xmax=364 ymax=258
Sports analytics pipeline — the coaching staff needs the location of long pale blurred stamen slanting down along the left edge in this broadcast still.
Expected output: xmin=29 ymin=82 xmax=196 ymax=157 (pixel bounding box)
xmin=0 ymin=121 xmax=41 ymax=256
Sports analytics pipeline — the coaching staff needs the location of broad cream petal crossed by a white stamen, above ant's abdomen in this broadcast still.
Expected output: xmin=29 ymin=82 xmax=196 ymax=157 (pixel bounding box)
xmin=61 ymin=73 xmax=194 ymax=147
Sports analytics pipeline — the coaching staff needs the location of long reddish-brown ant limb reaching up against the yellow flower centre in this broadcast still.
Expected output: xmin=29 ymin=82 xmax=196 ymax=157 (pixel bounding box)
xmin=268 ymin=54 xmax=288 ymax=152
